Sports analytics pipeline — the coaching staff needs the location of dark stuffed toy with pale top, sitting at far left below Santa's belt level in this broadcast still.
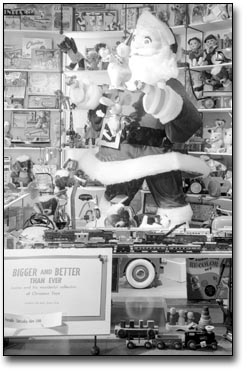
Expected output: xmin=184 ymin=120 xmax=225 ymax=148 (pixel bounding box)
xmin=11 ymin=155 xmax=35 ymax=187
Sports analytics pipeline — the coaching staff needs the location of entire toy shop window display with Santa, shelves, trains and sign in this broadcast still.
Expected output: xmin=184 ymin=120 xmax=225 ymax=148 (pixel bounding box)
xmin=4 ymin=3 xmax=233 ymax=356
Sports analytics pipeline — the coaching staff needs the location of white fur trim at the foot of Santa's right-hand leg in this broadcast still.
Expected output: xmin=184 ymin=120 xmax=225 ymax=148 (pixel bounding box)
xmin=157 ymin=205 xmax=193 ymax=229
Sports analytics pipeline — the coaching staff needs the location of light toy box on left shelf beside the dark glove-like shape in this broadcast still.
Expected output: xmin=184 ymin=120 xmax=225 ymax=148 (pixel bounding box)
xmin=31 ymin=49 xmax=60 ymax=71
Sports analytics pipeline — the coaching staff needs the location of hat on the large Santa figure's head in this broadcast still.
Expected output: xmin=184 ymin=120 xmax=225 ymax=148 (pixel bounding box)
xmin=136 ymin=10 xmax=176 ymax=46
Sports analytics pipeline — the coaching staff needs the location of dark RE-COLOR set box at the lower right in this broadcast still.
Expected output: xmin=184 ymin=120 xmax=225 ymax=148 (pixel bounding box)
xmin=186 ymin=258 xmax=230 ymax=300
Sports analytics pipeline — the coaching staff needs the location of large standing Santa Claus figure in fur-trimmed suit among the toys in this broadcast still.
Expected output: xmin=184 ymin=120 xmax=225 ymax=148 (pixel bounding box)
xmin=72 ymin=11 xmax=209 ymax=229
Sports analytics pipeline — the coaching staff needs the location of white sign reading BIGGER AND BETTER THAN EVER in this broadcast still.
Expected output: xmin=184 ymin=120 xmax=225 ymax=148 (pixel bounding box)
xmin=4 ymin=248 xmax=112 ymax=336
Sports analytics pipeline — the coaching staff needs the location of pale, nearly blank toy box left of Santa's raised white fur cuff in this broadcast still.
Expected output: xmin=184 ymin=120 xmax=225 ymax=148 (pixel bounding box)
xmin=28 ymin=72 xmax=60 ymax=96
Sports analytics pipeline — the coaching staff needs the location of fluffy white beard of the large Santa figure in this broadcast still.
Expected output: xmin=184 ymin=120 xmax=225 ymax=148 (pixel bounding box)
xmin=128 ymin=46 xmax=178 ymax=85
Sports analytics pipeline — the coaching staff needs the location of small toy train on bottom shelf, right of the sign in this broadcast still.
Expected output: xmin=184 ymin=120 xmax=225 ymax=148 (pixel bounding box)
xmin=115 ymin=320 xmax=218 ymax=350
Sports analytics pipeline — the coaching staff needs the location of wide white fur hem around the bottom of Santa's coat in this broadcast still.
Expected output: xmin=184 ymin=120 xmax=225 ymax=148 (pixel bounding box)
xmin=79 ymin=151 xmax=210 ymax=185
